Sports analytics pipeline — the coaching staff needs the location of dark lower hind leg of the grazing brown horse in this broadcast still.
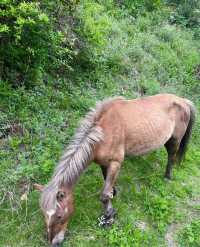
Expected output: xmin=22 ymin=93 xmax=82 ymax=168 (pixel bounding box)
xmin=165 ymin=137 xmax=179 ymax=179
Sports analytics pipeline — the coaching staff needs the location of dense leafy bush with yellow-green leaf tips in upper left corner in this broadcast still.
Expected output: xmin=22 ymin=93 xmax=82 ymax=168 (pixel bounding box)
xmin=0 ymin=0 xmax=71 ymax=85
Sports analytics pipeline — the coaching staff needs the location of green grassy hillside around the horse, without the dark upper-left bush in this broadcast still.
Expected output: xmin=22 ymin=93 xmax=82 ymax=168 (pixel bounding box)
xmin=0 ymin=1 xmax=200 ymax=247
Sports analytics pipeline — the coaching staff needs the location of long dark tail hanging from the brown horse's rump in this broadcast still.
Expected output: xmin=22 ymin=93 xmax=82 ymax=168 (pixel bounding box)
xmin=176 ymin=99 xmax=196 ymax=164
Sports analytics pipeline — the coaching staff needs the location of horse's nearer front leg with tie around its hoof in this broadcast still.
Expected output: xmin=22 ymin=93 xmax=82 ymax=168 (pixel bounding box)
xmin=99 ymin=161 xmax=121 ymax=226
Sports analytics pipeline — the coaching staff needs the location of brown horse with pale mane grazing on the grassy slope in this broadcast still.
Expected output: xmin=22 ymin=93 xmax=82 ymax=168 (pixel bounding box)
xmin=34 ymin=94 xmax=195 ymax=246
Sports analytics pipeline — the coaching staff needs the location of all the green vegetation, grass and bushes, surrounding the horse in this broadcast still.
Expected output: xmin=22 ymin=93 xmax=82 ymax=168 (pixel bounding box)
xmin=0 ymin=0 xmax=200 ymax=247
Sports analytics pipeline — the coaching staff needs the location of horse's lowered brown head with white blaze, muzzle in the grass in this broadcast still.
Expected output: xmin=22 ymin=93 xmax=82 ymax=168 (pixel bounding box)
xmin=35 ymin=182 xmax=74 ymax=247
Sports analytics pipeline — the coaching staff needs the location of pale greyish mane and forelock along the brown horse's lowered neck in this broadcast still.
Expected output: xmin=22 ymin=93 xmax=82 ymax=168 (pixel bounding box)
xmin=41 ymin=97 xmax=123 ymax=210
